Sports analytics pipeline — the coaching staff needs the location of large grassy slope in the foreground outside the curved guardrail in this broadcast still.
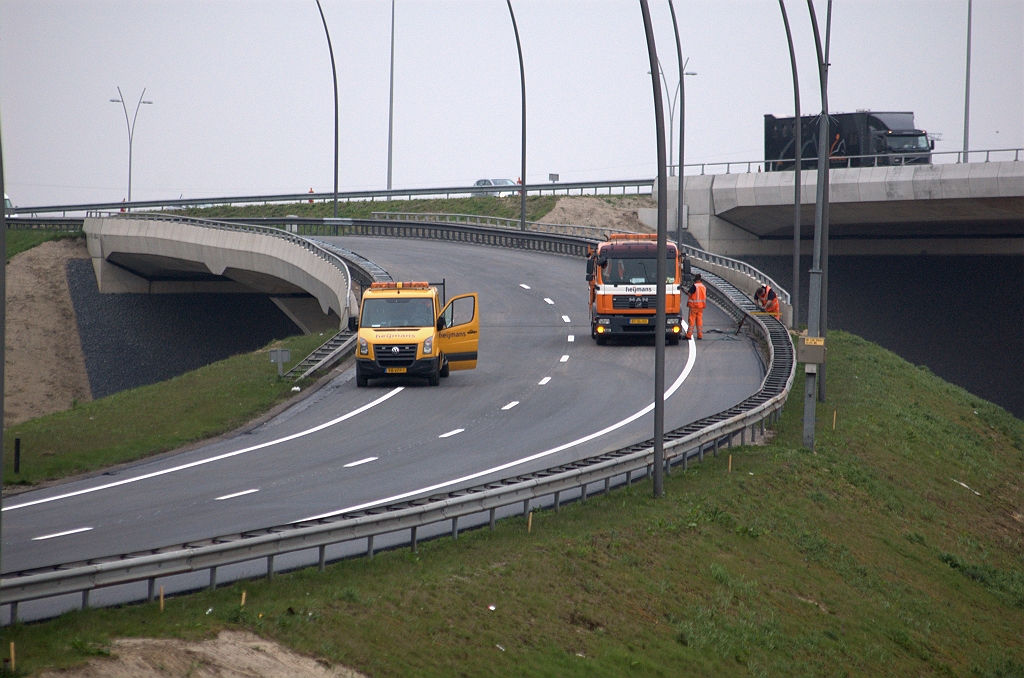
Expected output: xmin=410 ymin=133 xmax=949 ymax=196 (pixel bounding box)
xmin=2 ymin=332 xmax=1024 ymax=677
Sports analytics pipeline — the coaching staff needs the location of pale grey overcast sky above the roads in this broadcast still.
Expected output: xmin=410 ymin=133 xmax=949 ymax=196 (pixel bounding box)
xmin=0 ymin=0 xmax=1024 ymax=206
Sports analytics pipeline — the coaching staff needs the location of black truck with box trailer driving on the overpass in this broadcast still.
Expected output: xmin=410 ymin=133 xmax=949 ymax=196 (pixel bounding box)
xmin=765 ymin=111 xmax=935 ymax=172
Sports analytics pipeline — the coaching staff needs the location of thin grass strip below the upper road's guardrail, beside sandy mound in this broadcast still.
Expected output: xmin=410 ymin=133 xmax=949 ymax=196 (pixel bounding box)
xmin=171 ymin=196 xmax=559 ymax=221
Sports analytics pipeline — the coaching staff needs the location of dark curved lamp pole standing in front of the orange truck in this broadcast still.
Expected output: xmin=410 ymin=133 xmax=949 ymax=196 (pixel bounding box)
xmin=640 ymin=0 xmax=667 ymax=497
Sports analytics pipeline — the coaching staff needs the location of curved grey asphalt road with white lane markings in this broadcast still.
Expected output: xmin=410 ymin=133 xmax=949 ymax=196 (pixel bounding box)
xmin=2 ymin=238 xmax=764 ymax=573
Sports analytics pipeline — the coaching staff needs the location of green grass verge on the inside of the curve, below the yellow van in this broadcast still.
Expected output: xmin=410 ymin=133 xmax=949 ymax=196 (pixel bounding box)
xmin=3 ymin=335 xmax=326 ymax=485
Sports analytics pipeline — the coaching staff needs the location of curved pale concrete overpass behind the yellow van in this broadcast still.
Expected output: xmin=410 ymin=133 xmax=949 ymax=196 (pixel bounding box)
xmin=83 ymin=214 xmax=354 ymax=334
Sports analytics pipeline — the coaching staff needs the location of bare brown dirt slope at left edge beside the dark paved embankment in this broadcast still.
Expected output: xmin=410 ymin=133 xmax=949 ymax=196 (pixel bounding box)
xmin=3 ymin=239 xmax=92 ymax=427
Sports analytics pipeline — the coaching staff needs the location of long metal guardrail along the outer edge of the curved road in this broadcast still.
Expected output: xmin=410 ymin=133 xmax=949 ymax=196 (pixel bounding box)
xmin=0 ymin=213 xmax=797 ymax=620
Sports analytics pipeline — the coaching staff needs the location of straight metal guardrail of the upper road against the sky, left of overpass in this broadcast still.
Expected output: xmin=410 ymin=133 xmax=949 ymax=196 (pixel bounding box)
xmin=7 ymin=179 xmax=654 ymax=215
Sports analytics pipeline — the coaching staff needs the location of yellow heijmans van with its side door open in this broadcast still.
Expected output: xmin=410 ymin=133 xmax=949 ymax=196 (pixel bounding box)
xmin=348 ymin=283 xmax=480 ymax=387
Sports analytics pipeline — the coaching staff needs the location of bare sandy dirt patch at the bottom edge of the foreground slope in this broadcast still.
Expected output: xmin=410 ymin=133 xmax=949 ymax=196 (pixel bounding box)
xmin=38 ymin=631 xmax=366 ymax=678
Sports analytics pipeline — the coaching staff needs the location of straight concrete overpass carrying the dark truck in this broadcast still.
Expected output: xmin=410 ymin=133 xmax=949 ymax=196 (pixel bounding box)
xmin=640 ymin=161 xmax=1024 ymax=256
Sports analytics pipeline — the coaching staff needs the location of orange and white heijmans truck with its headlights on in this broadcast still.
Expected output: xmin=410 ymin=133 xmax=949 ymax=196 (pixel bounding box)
xmin=587 ymin=234 xmax=683 ymax=345
